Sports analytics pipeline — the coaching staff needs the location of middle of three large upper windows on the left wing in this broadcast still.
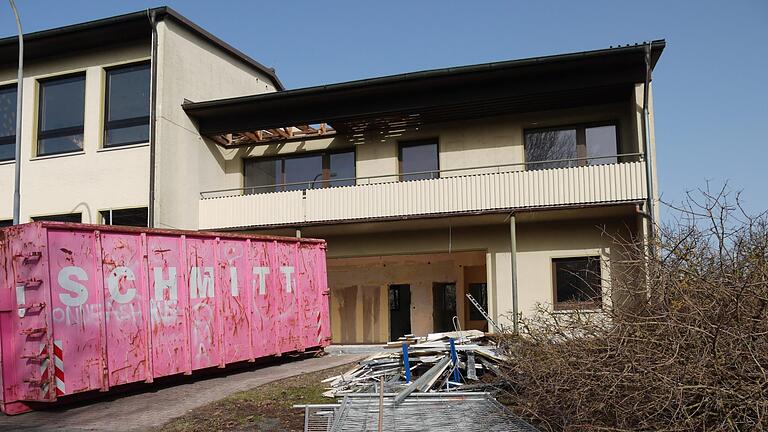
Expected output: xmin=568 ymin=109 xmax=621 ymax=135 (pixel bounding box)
xmin=37 ymin=75 xmax=85 ymax=156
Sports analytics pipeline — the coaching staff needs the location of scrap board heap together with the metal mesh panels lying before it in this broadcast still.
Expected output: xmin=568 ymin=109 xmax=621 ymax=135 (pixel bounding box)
xmin=295 ymin=330 xmax=536 ymax=432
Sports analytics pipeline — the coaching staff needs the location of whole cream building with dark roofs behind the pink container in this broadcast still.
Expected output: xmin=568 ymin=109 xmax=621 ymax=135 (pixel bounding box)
xmin=0 ymin=9 xmax=665 ymax=343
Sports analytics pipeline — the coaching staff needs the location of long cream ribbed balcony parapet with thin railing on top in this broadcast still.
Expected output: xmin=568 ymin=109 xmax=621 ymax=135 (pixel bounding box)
xmin=199 ymin=154 xmax=646 ymax=229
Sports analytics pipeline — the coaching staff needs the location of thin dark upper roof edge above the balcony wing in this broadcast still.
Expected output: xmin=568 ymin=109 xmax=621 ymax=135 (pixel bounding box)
xmin=182 ymin=39 xmax=666 ymax=112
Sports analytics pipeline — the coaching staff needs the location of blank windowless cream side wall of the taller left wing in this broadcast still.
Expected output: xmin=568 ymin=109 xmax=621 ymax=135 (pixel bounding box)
xmin=155 ymin=20 xmax=275 ymax=229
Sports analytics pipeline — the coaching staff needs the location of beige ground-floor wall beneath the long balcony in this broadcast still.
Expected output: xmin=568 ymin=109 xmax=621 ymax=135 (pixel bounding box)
xmin=326 ymin=218 xmax=636 ymax=333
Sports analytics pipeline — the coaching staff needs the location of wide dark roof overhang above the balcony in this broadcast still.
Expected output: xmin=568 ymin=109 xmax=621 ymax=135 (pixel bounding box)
xmin=184 ymin=40 xmax=665 ymax=144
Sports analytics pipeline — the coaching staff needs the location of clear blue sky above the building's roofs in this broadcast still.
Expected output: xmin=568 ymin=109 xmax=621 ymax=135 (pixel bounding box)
xmin=0 ymin=0 xmax=768 ymax=219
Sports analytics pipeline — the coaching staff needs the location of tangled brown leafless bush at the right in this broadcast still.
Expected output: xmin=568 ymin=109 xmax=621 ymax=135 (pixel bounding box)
xmin=503 ymin=189 xmax=768 ymax=431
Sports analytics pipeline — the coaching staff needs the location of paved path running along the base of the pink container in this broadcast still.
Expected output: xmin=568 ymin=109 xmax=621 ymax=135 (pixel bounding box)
xmin=0 ymin=354 xmax=364 ymax=432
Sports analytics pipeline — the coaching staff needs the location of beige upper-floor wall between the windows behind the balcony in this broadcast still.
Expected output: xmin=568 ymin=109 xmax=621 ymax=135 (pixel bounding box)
xmin=233 ymin=102 xmax=642 ymax=187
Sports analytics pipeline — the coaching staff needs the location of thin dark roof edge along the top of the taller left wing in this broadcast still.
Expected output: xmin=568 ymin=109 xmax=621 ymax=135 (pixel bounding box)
xmin=0 ymin=6 xmax=285 ymax=90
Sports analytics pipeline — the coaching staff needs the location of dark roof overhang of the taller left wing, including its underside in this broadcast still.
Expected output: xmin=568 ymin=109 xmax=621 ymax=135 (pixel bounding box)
xmin=0 ymin=6 xmax=284 ymax=90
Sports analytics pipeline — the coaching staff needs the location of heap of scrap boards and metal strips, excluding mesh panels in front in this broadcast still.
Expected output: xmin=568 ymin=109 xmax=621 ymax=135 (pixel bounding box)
xmin=324 ymin=330 xmax=504 ymax=401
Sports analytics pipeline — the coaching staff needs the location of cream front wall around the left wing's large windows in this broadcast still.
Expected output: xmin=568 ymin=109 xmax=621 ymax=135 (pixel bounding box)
xmin=0 ymin=42 xmax=150 ymax=223
